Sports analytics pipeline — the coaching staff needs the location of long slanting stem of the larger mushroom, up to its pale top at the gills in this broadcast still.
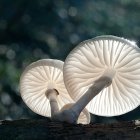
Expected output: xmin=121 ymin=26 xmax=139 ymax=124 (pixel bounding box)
xmin=60 ymin=69 xmax=116 ymax=123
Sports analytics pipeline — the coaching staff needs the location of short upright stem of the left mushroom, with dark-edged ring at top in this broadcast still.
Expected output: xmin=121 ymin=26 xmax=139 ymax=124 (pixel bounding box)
xmin=45 ymin=89 xmax=59 ymax=117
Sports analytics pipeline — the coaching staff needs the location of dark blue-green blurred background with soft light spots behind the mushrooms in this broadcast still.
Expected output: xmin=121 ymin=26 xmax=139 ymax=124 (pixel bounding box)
xmin=0 ymin=0 xmax=140 ymax=123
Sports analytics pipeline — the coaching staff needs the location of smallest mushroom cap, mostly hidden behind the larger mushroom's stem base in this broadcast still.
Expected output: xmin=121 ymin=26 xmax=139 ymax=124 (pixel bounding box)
xmin=61 ymin=103 xmax=91 ymax=124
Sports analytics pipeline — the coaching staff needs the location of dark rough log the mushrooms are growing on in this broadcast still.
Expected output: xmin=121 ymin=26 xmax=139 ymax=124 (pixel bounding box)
xmin=0 ymin=118 xmax=140 ymax=140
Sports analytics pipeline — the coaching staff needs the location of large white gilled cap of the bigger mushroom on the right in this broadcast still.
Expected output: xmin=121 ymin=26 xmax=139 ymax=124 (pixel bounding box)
xmin=63 ymin=35 xmax=140 ymax=116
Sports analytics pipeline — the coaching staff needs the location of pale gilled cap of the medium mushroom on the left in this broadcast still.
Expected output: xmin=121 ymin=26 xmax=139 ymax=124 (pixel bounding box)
xmin=20 ymin=59 xmax=73 ymax=117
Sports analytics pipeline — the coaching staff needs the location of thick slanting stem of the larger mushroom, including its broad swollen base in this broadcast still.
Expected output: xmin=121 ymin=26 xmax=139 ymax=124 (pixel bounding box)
xmin=57 ymin=76 xmax=112 ymax=123
